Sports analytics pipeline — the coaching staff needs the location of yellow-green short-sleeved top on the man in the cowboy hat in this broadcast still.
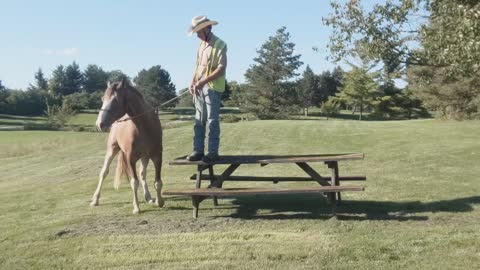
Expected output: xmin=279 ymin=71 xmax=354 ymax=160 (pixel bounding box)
xmin=195 ymin=33 xmax=227 ymax=81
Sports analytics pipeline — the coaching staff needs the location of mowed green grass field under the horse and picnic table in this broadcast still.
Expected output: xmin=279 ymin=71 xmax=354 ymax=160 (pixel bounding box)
xmin=0 ymin=120 xmax=480 ymax=269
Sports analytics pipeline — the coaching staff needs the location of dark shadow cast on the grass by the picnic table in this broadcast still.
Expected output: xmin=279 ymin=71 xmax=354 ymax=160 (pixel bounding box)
xmin=209 ymin=195 xmax=480 ymax=221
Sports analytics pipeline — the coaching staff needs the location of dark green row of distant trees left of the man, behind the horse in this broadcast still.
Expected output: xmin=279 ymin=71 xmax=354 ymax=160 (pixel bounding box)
xmin=0 ymin=62 xmax=176 ymax=115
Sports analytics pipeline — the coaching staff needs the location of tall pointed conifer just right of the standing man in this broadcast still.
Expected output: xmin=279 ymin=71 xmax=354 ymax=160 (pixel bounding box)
xmin=245 ymin=27 xmax=303 ymax=119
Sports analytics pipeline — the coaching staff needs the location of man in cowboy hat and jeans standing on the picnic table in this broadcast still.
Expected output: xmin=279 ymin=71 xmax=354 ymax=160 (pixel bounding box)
xmin=187 ymin=16 xmax=227 ymax=163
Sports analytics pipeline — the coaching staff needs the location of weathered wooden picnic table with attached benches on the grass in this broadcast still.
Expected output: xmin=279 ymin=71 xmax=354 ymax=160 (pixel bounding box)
xmin=163 ymin=153 xmax=367 ymax=218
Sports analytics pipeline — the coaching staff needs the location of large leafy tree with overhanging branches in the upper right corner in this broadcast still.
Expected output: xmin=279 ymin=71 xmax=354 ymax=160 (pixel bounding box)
xmin=324 ymin=0 xmax=480 ymax=118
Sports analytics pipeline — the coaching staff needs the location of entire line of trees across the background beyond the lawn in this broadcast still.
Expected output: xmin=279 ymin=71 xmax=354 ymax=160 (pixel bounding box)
xmin=0 ymin=0 xmax=480 ymax=119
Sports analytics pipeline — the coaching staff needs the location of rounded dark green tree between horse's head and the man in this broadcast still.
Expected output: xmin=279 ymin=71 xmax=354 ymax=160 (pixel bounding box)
xmin=134 ymin=65 xmax=176 ymax=109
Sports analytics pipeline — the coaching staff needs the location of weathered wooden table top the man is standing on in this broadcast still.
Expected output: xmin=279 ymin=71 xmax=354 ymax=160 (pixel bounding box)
xmin=169 ymin=153 xmax=365 ymax=165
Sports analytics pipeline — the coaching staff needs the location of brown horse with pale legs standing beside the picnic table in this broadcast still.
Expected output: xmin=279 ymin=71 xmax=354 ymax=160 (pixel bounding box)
xmin=90 ymin=79 xmax=164 ymax=214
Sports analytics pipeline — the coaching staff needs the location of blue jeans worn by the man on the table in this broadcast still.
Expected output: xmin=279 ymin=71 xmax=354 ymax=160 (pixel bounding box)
xmin=193 ymin=87 xmax=221 ymax=153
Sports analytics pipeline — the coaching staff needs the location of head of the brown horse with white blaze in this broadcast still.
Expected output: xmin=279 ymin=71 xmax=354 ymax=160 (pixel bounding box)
xmin=95 ymin=78 xmax=131 ymax=131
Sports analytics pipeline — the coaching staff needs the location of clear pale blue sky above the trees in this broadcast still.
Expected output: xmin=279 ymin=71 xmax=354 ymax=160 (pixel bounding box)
xmin=0 ymin=0 xmax=376 ymax=90
